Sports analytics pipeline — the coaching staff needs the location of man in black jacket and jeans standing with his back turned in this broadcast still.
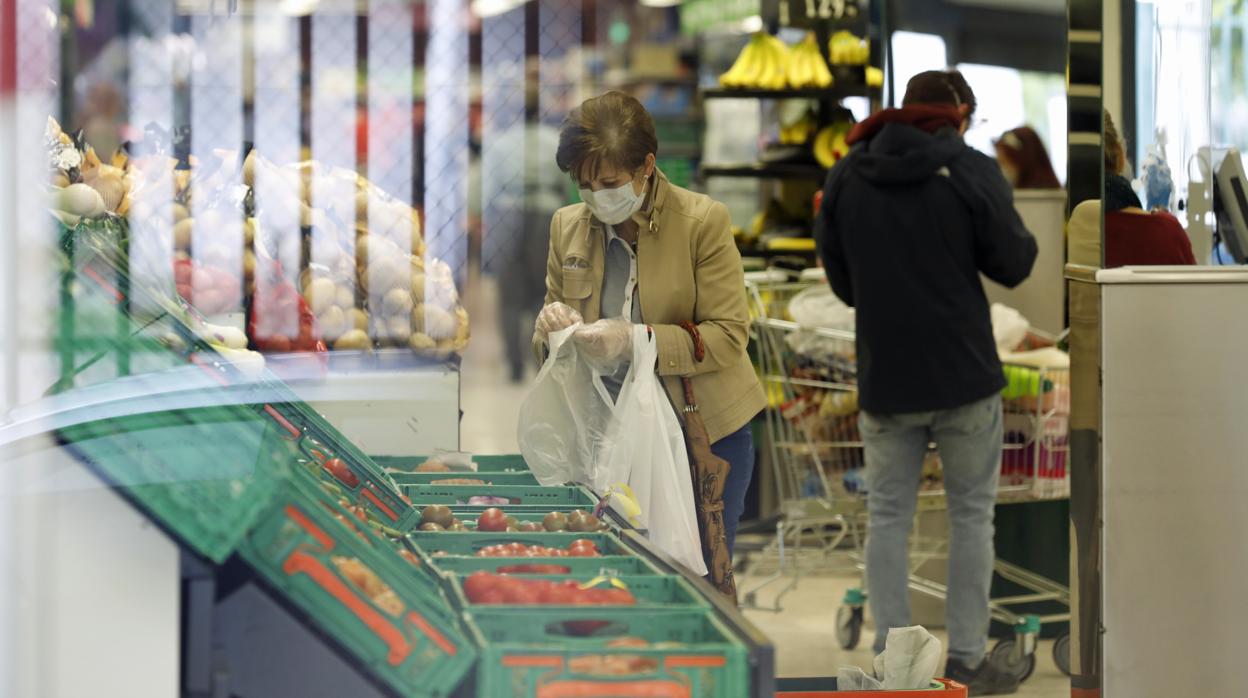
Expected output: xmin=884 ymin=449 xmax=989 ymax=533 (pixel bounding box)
xmin=815 ymin=71 xmax=1036 ymax=696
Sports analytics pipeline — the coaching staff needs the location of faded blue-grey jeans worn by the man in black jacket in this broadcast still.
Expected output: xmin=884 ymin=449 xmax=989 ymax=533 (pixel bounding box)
xmin=859 ymin=395 xmax=1003 ymax=667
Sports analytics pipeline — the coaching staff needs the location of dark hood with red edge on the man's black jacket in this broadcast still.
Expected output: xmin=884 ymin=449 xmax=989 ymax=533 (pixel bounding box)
xmin=851 ymin=105 xmax=966 ymax=184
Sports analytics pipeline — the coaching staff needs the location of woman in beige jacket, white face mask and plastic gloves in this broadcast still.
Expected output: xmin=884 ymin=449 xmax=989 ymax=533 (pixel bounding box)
xmin=534 ymin=91 xmax=766 ymax=561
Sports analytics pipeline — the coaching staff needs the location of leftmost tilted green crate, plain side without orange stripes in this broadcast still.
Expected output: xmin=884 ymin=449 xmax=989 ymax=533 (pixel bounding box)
xmin=60 ymin=405 xmax=296 ymax=562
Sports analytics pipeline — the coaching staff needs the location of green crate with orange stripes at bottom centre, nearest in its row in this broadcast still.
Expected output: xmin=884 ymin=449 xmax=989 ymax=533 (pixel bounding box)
xmin=466 ymin=606 xmax=750 ymax=698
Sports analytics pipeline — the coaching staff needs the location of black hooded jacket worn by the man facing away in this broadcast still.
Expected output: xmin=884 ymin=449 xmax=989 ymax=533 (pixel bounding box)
xmin=815 ymin=106 xmax=1036 ymax=415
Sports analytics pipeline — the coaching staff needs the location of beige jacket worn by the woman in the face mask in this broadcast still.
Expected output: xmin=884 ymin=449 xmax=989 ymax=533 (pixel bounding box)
xmin=533 ymin=170 xmax=766 ymax=442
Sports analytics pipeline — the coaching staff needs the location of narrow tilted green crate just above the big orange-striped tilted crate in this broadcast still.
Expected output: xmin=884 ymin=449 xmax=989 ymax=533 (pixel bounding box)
xmin=255 ymin=402 xmax=421 ymax=531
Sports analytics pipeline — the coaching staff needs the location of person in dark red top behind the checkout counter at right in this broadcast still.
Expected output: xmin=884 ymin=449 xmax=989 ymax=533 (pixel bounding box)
xmin=1066 ymin=111 xmax=1197 ymax=268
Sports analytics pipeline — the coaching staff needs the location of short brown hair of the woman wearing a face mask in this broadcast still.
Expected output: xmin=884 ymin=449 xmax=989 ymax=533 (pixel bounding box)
xmin=554 ymin=91 xmax=659 ymax=181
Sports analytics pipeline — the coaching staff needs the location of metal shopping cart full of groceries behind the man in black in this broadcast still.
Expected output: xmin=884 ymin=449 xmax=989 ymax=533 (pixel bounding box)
xmin=743 ymin=272 xmax=1070 ymax=678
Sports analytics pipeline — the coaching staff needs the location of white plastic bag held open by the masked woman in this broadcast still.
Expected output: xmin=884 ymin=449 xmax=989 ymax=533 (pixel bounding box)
xmin=518 ymin=325 xmax=706 ymax=574
